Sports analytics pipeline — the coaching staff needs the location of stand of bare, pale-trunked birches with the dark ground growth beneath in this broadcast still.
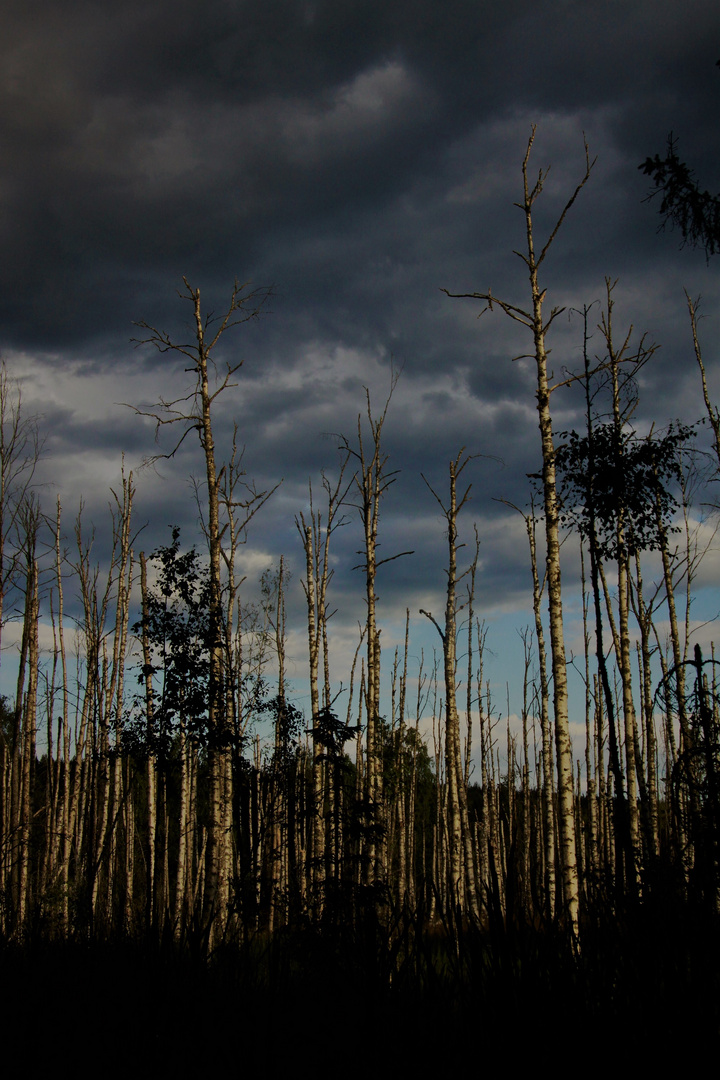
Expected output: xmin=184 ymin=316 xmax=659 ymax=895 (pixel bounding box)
xmin=0 ymin=139 xmax=720 ymax=1063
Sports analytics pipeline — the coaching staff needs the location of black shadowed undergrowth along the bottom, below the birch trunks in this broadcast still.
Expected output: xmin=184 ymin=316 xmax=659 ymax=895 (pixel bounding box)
xmin=0 ymin=885 xmax=720 ymax=1076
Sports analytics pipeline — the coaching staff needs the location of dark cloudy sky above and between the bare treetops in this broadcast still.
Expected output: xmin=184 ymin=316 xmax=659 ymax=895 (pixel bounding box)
xmin=0 ymin=0 xmax=720 ymax=734
